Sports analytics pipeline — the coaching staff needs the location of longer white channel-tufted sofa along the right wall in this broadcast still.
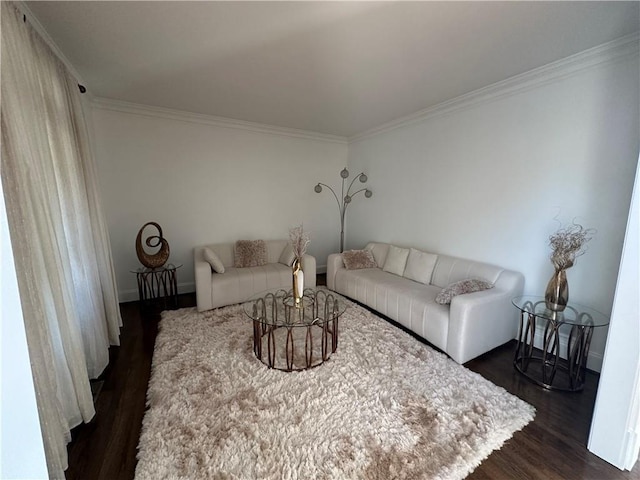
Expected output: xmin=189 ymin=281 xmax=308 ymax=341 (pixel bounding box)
xmin=327 ymin=243 xmax=524 ymax=364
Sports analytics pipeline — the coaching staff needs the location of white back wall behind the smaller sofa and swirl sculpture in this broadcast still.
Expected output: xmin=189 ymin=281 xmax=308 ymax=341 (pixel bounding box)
xmin=93 ymin=101 xmax=347 ymax=301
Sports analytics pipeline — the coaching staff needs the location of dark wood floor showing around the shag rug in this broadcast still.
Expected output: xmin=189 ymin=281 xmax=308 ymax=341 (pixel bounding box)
xmin=66 ymin=284 xmax=640 ymax=480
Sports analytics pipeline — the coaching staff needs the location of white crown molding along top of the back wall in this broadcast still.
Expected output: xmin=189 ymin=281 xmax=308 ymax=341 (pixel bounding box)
xmin=91 ymin=97 xmax=348 ymax=145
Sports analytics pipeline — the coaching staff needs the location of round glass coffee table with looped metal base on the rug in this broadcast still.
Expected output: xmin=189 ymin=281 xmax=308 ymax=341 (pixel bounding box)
xmin=242 ymin=288 xmax=347 ymax=372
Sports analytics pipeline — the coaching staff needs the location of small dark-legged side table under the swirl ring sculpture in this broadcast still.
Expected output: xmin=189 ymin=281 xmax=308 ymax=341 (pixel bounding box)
xmin=131 ymin=263 xmax=182 ymax=310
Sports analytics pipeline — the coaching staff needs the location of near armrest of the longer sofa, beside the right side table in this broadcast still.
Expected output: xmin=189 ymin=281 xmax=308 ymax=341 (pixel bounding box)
xmin=447 ymin=271 xmax=524 ymax=364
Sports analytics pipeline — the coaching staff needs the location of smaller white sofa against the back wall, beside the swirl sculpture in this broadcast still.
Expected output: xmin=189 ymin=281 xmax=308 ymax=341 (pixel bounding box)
xmin=193 ymin=240 xmax=316 ymax=312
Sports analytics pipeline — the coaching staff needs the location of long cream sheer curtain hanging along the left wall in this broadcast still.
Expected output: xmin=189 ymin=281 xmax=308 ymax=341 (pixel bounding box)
xmin=0 ymin=2 xmax=122 ymax=478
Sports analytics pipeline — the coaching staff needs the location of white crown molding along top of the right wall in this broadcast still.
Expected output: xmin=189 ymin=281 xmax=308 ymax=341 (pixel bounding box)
xmin=349 ymin=33 xmax=640 ymax=143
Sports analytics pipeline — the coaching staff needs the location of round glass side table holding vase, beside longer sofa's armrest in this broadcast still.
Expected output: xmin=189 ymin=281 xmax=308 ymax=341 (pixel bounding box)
xmin=512 ymin=295 xmax=609 ymax=392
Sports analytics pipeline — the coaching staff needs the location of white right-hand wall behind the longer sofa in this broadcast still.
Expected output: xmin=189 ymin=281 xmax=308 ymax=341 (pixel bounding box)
xmin=347 ymin=46 xmax=640 ymax=370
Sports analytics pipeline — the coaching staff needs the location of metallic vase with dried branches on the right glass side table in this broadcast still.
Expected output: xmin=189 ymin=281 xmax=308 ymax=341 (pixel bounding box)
xmin=544 ymin=222 xmax=596 ymax=312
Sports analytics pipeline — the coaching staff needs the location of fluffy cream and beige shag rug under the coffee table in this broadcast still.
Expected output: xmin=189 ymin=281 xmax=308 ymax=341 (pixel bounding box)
xmin=136 ymin=302 xmax=535 ymax=480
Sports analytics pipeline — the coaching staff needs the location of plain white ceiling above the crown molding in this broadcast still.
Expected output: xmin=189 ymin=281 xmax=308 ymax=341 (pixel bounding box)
xmin=27 ymin=1 xmax=640 ymax=137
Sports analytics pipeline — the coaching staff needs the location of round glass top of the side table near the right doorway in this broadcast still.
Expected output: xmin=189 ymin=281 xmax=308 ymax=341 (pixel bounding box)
xmin=511 ymin=295 xmax=609 ymax=327
